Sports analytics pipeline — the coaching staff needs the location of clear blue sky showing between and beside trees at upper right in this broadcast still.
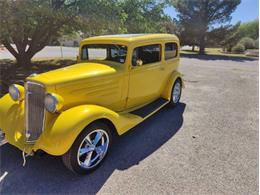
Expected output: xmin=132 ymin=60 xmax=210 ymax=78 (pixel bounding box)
xmin=165 ymin=0 xmax=259 ymax=24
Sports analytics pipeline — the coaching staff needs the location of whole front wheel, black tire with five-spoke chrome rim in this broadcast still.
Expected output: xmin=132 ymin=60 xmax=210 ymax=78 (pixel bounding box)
xmin=62 ymin=122 xmax=112 ymax=174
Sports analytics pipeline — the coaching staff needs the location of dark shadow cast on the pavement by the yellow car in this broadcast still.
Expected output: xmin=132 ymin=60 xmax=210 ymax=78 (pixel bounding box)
xmin=0 ymin=103 xmax=186 ymax=194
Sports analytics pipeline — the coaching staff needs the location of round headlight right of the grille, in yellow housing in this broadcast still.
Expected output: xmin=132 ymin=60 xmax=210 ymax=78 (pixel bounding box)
xmin=44 ymin=93 xmax=63 ymax=113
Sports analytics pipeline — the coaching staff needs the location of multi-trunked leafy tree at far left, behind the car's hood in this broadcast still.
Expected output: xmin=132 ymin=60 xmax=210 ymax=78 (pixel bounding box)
xmin=0 ymin=0 xmax=78 ymax=67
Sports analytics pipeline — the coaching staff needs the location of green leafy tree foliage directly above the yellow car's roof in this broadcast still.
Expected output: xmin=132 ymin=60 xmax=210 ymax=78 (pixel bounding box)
xmin=79 ymin=0 xmax=173 ymax=36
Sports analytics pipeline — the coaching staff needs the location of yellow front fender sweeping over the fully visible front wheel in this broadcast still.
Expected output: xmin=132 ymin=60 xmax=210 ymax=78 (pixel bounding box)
xmin=33 ymin=105 xmax=142 ymax=155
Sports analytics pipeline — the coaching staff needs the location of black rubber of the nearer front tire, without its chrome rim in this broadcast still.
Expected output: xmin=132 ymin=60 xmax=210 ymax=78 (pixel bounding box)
xmin=62 ymin=122 xmax=112 ymax=174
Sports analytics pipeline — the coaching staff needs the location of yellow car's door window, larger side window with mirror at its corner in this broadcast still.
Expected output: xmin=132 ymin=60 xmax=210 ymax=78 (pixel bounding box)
xmin=132 ymin=44 xmax=161 ymax=66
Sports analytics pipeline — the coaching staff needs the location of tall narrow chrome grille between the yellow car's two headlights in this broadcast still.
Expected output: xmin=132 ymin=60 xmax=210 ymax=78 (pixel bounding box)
xmin=25 ymin=82 xmax=45 ymax=142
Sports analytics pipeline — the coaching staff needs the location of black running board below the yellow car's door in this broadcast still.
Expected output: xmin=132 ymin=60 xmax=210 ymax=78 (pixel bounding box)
xmin=130 ymin=98 xmax=169 ymax=118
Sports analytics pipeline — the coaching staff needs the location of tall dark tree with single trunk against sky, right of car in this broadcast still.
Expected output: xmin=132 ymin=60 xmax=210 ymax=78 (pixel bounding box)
xmin=171 ymin=0 xmax=241 ymax=54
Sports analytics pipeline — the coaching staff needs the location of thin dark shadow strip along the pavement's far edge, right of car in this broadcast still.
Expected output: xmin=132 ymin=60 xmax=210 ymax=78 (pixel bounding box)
xmin=181 ymin=54 xmax=258 ymax=62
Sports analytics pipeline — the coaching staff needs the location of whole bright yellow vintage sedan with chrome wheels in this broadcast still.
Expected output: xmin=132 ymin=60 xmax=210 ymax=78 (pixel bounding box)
xmin=0 ymin=34 xmax=183 ymax=174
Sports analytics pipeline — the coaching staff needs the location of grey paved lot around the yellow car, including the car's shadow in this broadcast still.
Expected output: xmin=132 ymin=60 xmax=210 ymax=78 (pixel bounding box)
xmin=0 ymin=56 xmax=258 ymax=195
